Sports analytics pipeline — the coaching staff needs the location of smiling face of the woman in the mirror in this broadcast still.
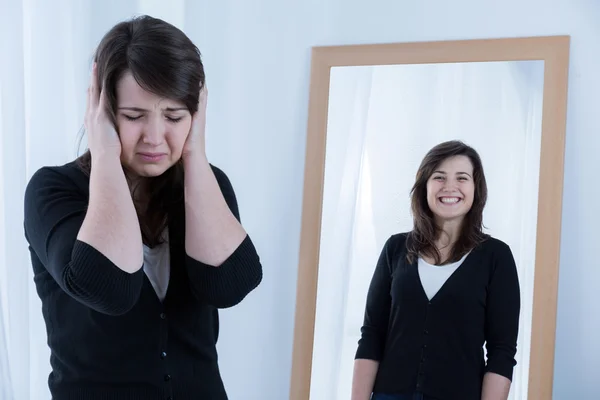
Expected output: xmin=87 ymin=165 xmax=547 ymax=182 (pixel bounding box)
xmin=427 ymin=156 xmax=475 ymax=223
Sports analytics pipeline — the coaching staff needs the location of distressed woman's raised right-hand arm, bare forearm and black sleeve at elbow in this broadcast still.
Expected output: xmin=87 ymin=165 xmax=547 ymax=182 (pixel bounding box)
xmin=184 ymin=156 xmax=262 ymax=308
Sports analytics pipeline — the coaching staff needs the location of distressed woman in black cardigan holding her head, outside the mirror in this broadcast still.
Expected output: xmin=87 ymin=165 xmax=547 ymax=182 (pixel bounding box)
xmin=25 ymin=16 xmax=262 ymax=400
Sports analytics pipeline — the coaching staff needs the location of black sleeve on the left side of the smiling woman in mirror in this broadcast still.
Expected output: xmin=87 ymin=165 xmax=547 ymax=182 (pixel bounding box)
xmin=355 ymin=237 xmax=393 ymax=361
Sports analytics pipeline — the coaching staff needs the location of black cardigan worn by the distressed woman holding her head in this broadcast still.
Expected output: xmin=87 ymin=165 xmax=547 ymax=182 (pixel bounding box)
xmin=25 ymin=163 xmax=262 ymax=400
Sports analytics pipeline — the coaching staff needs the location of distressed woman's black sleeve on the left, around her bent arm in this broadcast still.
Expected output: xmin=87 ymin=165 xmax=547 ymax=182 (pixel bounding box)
xmin=24 ymin=167 xmax=143 ymax=315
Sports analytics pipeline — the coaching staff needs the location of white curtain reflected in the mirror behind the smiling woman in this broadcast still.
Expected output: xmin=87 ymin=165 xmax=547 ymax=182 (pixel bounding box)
xmin=311 ymin=61 xmax=544 ymax=400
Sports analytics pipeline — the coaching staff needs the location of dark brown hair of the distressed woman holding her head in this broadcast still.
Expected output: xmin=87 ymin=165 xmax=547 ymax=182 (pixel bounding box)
xmin=77 ymin=15 xmax=205 ymax=247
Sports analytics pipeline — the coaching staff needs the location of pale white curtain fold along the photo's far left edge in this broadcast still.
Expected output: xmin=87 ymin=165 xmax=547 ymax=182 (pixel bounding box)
xmin=0 ymin=0 xmax=31 ymax=399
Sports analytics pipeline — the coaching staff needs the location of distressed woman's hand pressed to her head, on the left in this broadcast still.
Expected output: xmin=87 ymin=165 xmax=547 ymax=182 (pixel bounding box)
xmin=84 ymin=63 xmax=121 ymax=160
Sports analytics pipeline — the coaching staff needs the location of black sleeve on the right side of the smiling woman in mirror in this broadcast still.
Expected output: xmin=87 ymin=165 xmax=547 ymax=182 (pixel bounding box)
xmin=485 ymin=244 xmax=521 ymax=380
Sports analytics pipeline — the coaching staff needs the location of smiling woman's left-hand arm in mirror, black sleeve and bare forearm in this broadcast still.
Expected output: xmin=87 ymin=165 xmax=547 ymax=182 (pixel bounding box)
xmin=352 ymin=234 xmax=393 ymax=400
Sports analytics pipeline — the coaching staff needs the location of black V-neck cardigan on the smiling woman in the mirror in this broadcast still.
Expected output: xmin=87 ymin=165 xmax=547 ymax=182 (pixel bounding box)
xmin=356 ymin=234 xmax=520 ymax=400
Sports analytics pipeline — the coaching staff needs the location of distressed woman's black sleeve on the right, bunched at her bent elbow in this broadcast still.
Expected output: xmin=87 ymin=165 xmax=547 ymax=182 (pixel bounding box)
xmin=186 ymin=166 xmax=263 ymax=308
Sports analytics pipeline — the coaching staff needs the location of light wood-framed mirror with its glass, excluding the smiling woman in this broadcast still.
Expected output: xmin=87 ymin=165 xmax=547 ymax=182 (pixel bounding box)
xmin=290 ymin=37 xmax=568 ymax=400
